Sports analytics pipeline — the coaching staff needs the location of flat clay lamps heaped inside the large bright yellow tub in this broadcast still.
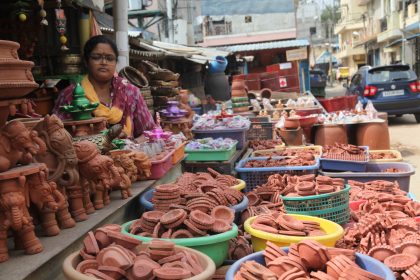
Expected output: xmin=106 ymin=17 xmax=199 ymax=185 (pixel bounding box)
xmin=251 ymin=214 xmax=326 ymax=236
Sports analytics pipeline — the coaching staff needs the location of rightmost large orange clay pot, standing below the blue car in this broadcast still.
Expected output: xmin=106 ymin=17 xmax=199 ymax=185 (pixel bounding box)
xmin=356 ymin=121 xmax=390 ymax=150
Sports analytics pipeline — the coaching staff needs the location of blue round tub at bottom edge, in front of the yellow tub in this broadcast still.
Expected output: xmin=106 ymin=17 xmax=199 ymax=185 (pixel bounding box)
xmin=225 ymin=248 xmax=395 ymax=280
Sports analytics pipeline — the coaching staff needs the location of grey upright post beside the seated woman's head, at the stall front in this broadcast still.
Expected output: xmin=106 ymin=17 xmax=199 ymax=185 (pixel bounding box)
xmin=113 ymin=0 xmax=129 ymax=71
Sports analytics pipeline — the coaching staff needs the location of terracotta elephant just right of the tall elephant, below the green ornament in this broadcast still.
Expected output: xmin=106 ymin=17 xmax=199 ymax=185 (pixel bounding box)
xmin=74 ymin=140 xmax=122 ymax=209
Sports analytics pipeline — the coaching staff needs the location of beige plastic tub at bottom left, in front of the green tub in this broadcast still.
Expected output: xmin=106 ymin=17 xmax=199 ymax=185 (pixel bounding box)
xmin=63 ymin=245 xmax=216 ymax=280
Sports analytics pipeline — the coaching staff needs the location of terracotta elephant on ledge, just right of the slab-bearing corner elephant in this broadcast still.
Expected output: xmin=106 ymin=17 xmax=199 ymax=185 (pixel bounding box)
xmin=27 ymin=167 xmax=76 ymax=236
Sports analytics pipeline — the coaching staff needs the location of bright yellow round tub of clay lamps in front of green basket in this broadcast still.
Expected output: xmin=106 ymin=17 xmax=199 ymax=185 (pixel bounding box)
xmin=244 ymin=214 xmax=344 ymax=252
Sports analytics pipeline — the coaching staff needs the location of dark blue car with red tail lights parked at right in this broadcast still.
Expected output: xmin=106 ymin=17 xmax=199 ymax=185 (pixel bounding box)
xmin=343 ymin=65 xmax=420 ymax=123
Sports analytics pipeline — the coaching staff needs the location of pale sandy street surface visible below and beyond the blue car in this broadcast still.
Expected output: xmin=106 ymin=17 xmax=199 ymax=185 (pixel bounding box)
xmin=326 ymin=84 xmax=420 ymax=197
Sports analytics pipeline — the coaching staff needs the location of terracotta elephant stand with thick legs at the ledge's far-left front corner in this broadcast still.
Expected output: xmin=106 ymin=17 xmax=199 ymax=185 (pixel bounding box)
xmin=0 ymin=174 xmax=44 ymax=262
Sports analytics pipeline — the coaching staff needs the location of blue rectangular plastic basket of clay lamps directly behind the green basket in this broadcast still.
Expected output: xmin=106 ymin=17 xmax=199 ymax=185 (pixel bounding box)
xmin=235 ymin=157 xmax=319 ymax=192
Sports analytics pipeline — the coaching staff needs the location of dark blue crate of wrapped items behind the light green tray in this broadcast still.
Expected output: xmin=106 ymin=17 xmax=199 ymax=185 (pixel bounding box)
xmin=192 ymin=127 xmax=249 ymax=150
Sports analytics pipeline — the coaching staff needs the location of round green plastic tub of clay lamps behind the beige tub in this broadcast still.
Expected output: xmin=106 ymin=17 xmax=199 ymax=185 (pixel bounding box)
xmin=121 ymin=221 xmax=238 ymax=267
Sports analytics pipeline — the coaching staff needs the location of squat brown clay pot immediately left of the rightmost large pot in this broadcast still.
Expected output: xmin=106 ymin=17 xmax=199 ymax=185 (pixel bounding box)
xmin=315 ymin=124 xmax=348 ymax=146
